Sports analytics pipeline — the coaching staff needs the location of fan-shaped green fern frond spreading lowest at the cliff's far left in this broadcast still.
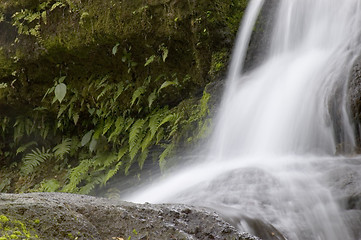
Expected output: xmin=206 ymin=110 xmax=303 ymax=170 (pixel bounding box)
xmin=20 ymin=148 xmax=53 ymax=175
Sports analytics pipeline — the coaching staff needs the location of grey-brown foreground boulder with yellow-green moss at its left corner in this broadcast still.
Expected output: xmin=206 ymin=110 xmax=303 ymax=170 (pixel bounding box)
xmin=0 ymin=193 xmax=258 ymax=240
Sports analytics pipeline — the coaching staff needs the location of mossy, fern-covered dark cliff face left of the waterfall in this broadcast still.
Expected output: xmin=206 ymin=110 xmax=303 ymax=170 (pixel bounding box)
xmin=0 ymin=0 xmax=247 ymax=193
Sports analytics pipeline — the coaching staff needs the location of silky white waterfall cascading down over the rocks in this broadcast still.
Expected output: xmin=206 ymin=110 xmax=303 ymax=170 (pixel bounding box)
xmin=126 ymin=0 xmax=361 ymax=240
